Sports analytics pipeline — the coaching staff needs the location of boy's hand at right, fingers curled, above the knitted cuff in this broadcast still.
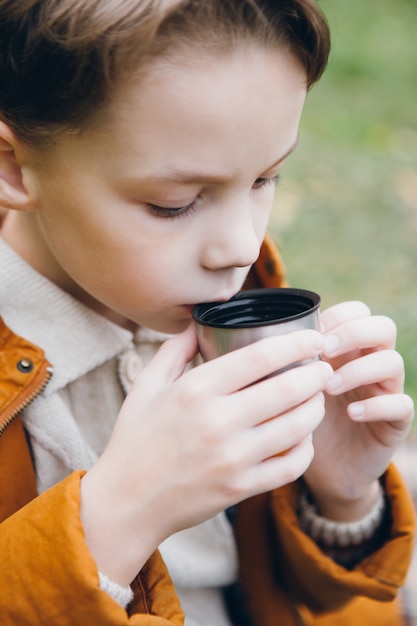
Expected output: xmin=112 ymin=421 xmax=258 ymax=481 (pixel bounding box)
xmin=305 ymin=302 xmax=413 ymax=521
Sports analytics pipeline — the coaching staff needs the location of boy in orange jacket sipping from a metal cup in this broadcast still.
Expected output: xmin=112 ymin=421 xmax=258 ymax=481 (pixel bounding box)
xmin=0 ymin=0 xmax=413 ymax=626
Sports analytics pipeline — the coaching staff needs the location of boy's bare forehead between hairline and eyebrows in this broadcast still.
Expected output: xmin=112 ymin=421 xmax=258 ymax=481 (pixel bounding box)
xmin=44 ymin=45 xmax=306 ymax=176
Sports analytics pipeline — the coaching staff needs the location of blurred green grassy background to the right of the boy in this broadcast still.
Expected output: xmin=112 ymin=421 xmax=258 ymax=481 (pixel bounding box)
xmin=270 ymin=0 xmax=417 ymax=420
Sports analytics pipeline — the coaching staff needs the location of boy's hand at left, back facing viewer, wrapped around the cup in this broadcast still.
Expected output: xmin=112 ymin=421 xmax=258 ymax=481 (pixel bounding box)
xmin=81 ymin=327 xmax=333 ymax=584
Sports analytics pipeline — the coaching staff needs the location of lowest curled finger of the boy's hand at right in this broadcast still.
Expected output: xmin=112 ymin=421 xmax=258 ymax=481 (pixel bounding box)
xmin=348 ymin=393 xmax=414 ymax=428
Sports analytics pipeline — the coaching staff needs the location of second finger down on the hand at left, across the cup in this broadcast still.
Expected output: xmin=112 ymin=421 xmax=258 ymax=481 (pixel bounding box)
xmin=232 ymin=361 xmax=333 ymax=426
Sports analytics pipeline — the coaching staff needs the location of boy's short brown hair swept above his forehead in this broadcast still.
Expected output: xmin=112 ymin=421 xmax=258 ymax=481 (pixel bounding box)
xmin=0 ymin=0 xmax=330 ymax=145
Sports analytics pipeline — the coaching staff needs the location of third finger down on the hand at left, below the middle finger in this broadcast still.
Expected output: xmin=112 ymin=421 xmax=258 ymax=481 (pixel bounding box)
xmin=247 ymin=393 xmax=325 ymax=462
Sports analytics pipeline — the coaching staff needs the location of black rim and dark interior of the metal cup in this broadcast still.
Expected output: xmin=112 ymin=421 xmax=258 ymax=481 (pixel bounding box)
xmin=192 ymin=287 xmax=320 ymax=329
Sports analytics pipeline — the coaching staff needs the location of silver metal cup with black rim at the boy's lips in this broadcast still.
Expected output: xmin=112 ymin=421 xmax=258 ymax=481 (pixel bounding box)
xmin=192 ymin=287 xmax=320 ymax=373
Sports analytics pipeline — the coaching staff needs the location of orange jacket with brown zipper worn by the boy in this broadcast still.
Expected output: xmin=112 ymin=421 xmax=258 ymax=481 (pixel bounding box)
xmin=0 ymin=235 xmax=414 ymax=626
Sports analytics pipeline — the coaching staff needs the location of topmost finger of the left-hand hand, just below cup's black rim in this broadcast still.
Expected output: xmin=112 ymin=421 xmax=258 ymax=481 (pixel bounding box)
xmin=187 ymin=330 xmax=323 ymax=395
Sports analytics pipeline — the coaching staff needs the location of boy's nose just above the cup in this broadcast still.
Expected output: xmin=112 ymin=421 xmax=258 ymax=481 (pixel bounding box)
xmin=201 ymin=200 xmax=262 ymax=270
